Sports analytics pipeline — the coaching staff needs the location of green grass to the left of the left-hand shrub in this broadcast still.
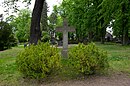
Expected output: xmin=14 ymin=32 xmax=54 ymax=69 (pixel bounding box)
xmin=0 ymin=47 xmax=23 ymax=86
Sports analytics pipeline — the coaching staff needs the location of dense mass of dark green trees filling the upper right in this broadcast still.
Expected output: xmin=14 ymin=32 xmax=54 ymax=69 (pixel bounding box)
xmin=50 ymin=0 xmax=130 ymax=45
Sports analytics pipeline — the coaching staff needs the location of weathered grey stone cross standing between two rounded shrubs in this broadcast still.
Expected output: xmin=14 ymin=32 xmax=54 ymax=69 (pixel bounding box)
xmin=56 ymin=19 xmax=75 ymax=57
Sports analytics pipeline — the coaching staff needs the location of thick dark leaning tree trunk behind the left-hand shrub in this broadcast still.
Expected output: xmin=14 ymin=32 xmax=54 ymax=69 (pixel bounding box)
xmin=30 ymin=0 xmax=45 ymax=45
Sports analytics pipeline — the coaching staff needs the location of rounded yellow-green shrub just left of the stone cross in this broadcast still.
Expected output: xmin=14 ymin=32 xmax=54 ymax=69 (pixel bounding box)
xmin=16 ymin=43 xmax=61 ymax=78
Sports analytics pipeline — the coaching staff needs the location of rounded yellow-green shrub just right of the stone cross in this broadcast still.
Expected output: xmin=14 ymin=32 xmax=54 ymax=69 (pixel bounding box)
xmin=69 ymin=43 xmax=108 ymax=75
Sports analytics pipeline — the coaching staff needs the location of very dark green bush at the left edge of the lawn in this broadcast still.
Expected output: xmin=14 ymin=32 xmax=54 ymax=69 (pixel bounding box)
xmin=0 ymin=21 xmax=17 ymax=50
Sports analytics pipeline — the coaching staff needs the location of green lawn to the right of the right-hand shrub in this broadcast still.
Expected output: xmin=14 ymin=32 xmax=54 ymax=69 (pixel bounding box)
xmin=97 ymin=43 xmax=130 ymax=74
